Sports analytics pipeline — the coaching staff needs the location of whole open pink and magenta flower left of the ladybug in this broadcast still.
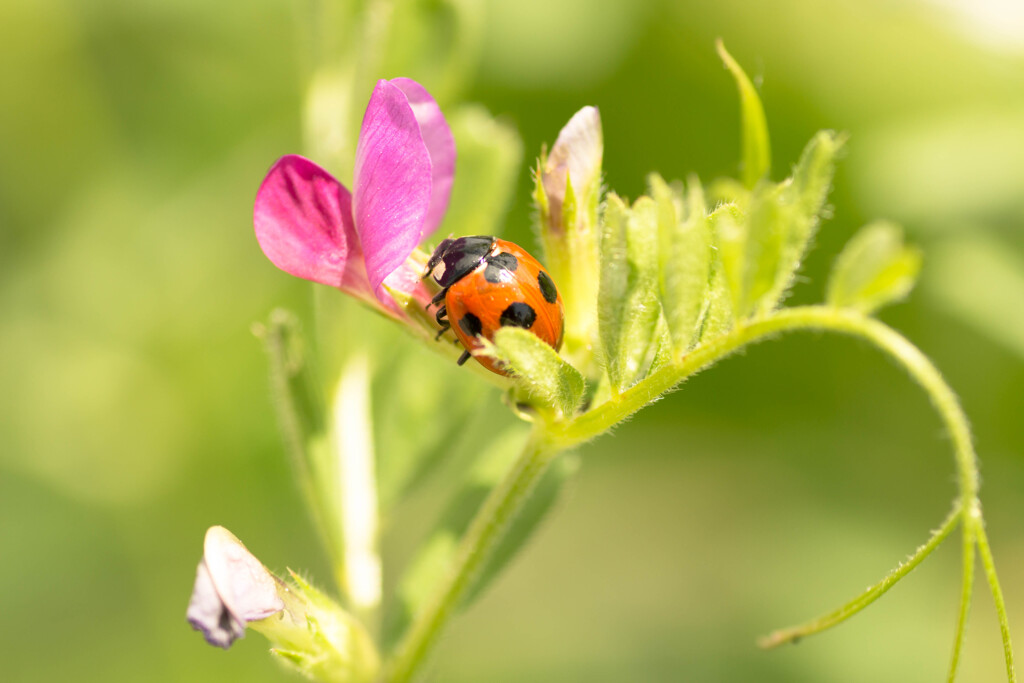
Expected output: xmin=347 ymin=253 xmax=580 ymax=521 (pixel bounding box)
xmin=253 ymin=78 xmax=455 ymax=315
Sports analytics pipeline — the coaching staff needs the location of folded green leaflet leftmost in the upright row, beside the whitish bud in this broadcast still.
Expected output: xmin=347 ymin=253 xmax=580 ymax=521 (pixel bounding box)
xmin=598 ymin=195 xmax=660 ymax=392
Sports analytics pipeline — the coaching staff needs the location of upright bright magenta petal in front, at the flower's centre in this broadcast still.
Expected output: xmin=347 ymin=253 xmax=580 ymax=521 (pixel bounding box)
xmin=352 ymin=81 xmax=432 ymax=303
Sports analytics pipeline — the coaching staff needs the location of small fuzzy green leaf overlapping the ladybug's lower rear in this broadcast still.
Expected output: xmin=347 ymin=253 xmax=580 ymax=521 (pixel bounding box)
xmin=494 ymin=328 xmax=586 ymax=415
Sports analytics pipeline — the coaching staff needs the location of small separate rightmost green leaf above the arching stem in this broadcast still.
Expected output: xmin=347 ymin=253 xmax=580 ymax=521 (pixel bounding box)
xmin=825 ymin=221 xmax=921 ymax=313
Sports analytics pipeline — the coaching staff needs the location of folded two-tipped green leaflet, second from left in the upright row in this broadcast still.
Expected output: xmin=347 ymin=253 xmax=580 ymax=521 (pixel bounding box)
xmin=649 ymin=174 xmax=712 ymax=353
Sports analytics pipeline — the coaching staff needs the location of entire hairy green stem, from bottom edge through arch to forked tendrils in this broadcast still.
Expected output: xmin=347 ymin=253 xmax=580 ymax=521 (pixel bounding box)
xmin=384 ymin=306 xmax=1015 ymax=683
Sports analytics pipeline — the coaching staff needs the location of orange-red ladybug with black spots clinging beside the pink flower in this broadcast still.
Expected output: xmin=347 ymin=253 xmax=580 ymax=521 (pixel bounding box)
xmin=423 ymin=234 xmax=564 ymax=375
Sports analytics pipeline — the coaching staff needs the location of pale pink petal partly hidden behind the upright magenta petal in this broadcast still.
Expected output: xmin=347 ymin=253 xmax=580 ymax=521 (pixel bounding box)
xmin=391 ymin=78 xmax=456 ymax=240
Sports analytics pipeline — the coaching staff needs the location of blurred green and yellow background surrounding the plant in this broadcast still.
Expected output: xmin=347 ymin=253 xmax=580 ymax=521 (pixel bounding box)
xmin=0 ymin=0 xmax=1024 ymax=681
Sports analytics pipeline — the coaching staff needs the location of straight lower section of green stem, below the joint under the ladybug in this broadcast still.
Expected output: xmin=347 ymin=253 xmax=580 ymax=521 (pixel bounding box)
xmin=383 ymin=427 xmax=558 ymax=683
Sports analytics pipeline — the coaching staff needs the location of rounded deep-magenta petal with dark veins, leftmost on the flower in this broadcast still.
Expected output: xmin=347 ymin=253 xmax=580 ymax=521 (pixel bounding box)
xmin=253 ymin=155 xmax=369 ymax=290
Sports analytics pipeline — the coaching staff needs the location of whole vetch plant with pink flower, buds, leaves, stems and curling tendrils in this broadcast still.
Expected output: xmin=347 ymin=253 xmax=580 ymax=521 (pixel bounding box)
xmin=187 ymin=31 xmax=1015 ymax=683
